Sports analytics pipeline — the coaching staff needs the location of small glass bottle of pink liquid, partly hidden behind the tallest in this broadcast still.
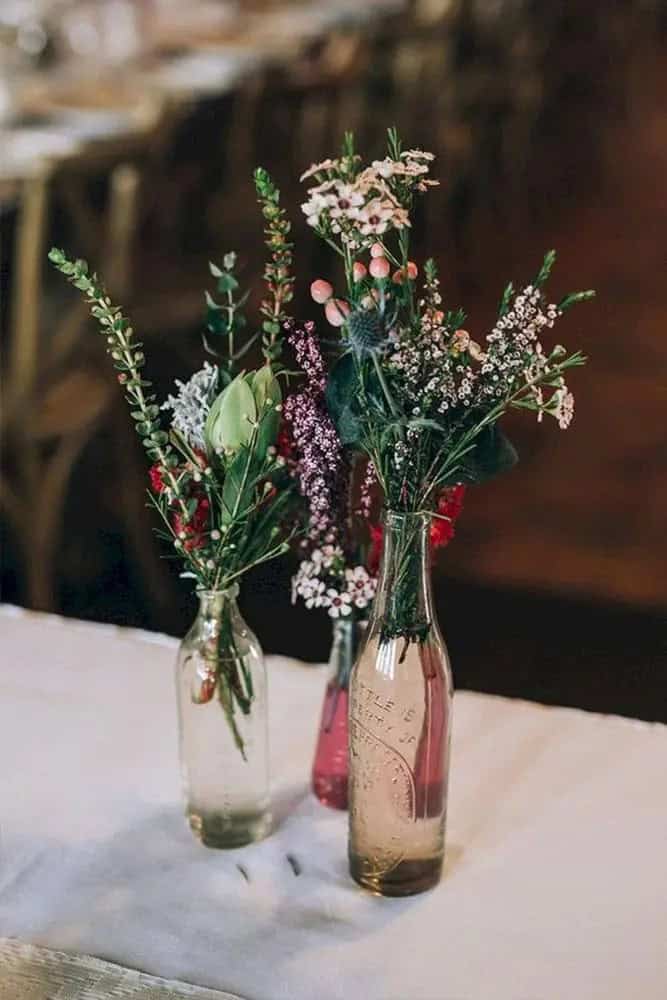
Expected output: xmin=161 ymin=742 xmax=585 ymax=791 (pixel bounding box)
xmin=312 ymin=612 xmax=367 ymax=809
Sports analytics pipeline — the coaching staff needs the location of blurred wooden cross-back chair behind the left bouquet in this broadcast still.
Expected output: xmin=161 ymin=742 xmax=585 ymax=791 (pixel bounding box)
xmin=0 ymin=149 xmax=172 ymax=610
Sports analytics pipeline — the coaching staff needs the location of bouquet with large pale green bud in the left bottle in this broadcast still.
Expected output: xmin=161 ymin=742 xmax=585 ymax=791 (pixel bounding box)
xmin=49 ymin=169 xmax=294 ymax=750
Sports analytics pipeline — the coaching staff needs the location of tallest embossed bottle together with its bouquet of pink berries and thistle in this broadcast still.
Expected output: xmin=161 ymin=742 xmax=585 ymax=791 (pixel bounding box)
xmin=302 ymin=129 xmax=593 ymax=895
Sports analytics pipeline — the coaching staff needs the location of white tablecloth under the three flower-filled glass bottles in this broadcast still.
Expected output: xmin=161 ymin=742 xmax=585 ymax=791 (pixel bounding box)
xmin=0 ymin=608 xmax=667 ymax=1000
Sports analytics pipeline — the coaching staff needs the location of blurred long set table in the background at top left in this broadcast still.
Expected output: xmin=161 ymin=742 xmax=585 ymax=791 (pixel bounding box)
xmin=0 ymin=0 xmax=404 ymax=200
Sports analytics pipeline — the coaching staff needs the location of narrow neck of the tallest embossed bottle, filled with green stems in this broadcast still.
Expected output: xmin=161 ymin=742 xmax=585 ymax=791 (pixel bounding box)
xmin=373 ymin=511 xmax=434 ymax=639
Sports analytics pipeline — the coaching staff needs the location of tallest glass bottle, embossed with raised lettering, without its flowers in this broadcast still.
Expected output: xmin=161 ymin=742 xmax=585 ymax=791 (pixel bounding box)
xmin=349 ymin=512 xmax=452 ymax=896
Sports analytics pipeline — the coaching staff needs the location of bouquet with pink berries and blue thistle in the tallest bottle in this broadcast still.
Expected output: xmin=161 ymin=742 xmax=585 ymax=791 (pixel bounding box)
xmin=302 ymin=130 xmax=593 ymax=636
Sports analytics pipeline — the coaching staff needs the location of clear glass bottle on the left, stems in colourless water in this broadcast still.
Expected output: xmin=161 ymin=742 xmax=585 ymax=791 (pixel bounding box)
xmin=176 ymin=585 xmax=271 ymax=847
